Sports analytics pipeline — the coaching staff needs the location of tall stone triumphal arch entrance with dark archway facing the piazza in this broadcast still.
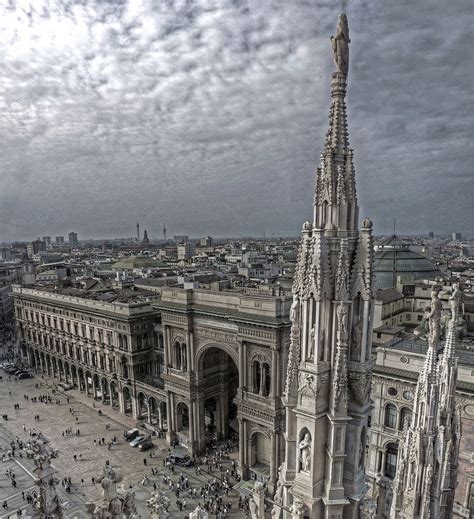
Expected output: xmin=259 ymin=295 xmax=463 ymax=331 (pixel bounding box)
xmin=157 ymin=287 xmax=291 ymax=494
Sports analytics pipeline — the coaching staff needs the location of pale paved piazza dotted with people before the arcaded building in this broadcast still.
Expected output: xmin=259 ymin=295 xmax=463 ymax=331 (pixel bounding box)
xmin=0 ymin=370 xmax=252 ymax=519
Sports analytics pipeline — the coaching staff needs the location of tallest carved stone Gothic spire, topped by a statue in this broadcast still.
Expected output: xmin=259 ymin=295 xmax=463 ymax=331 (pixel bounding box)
xmin=275 ymin=14 xmax=374 ymax=519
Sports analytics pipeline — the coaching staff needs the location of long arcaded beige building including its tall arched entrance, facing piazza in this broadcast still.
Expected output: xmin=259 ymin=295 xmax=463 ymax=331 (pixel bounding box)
xmin=13 ymin=286 xmax=291 ymax=489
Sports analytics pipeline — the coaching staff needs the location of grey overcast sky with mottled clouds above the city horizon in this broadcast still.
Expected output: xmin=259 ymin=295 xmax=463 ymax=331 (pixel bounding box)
xmin=0 ymin=0 xmax=474 ymax=241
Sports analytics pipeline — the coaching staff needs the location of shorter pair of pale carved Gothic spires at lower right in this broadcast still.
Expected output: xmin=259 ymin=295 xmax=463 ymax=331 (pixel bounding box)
xmin=390 ymin=284 xmax=462 ymax=519
